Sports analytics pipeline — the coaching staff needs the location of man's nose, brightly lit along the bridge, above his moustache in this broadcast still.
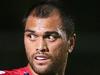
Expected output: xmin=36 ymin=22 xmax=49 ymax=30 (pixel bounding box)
xmin=36 ymin=38 xmax=49 ymax=52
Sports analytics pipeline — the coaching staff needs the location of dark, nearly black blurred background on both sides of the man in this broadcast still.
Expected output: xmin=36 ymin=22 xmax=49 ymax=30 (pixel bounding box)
xmin=0 ymin=0 xmax=100 ymax=75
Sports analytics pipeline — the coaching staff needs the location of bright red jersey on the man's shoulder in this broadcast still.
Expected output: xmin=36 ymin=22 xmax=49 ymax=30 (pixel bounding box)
xmin=0 ymin=65 xmax=32 ymax=75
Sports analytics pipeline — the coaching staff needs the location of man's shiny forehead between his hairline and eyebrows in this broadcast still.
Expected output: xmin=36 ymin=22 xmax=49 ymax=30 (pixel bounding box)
xmin=25 ymin=14 xmax=62 ymax=29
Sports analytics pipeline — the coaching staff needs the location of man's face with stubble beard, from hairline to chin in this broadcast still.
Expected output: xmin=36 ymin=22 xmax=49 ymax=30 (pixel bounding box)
xmin=24 ymin=15 xmax=69 ymax=74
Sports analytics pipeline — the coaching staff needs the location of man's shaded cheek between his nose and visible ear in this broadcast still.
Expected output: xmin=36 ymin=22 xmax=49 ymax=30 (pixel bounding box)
xmin=49 ymin=41 xmax=67 ymax=57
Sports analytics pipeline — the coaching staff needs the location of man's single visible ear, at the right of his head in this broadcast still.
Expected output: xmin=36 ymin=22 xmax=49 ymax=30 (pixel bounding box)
xmin=68 ymin=33 xmax=76 ymax=53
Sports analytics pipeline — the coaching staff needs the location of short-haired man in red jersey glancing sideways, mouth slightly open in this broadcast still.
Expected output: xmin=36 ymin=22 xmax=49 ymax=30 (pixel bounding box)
xmin=1 ymin=2 xmax=75 ymax=75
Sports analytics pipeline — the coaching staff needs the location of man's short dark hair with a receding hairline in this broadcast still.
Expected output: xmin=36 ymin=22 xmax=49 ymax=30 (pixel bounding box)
xmin=23 ymin=1 xmax=74 ymax=36
